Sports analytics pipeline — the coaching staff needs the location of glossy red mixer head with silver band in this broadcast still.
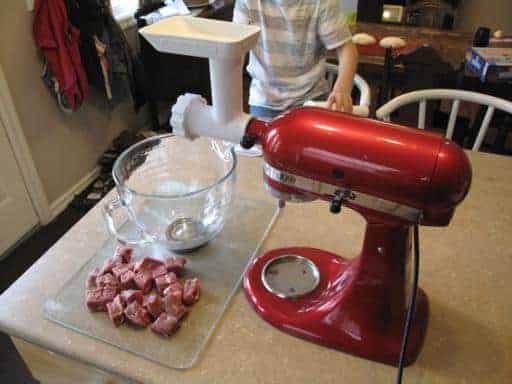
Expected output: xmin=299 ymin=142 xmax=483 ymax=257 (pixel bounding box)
xmin=242 ymin=108 xmax=471 ymax=226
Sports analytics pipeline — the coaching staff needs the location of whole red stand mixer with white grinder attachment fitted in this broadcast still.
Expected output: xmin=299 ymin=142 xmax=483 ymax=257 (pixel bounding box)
xmin=141 ymin=16 xmax=471 ymax=365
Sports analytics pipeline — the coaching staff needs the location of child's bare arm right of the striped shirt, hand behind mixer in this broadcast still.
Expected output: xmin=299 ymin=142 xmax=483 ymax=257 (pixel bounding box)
xmin=327 ymin=41 xmax=358 ymax=113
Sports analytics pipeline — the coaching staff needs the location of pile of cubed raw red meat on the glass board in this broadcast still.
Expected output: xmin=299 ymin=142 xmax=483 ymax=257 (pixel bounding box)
xmin=86 ymin=247 xmax=201 ymax=336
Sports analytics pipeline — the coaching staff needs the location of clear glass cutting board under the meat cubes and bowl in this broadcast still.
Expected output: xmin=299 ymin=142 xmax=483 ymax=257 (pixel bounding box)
xmin=44 ymin=195 xmax=278 ymax=369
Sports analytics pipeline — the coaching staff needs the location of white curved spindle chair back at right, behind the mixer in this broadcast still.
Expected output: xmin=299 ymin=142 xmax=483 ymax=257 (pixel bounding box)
xmin=376 ymin=89 xmax=512 ymax=151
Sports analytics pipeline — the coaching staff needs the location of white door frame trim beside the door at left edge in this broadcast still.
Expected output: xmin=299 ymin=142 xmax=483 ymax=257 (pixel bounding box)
xmin=0 ymin=66 xmax=51 ymax=225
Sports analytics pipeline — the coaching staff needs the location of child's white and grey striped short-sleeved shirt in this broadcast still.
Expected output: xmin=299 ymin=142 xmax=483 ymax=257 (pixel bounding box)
xmin=233 ymin=0 xmax=351 ymax=110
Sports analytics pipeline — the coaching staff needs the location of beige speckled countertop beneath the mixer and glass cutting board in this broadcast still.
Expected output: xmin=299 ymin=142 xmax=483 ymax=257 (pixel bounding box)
xmin=0 ymin=153 xmax=512 ymax=384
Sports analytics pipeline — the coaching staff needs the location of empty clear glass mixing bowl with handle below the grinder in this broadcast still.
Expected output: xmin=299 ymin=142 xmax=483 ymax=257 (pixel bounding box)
xmin=104 ymin=135 xmax=236 ymax=251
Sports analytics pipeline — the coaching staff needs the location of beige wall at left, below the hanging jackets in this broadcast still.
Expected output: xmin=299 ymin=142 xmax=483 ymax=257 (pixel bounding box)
xmin=0 ymin=0 xmax=147 ymax=204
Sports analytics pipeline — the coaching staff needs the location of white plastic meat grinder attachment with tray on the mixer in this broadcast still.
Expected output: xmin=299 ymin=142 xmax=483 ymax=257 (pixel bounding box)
xmin=140 ymin=16 xmax=260 ymax=144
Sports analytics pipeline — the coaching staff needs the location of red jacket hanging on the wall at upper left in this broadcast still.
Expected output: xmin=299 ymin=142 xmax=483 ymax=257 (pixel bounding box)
xmin=33 ymin=0 xmax=89 ymax=109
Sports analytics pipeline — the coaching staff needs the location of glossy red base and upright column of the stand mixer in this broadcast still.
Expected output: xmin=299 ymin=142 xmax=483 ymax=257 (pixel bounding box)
xmin=244 ymin=225 xmax=429 ymax=365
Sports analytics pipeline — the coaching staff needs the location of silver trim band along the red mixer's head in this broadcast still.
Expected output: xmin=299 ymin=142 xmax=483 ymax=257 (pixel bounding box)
xmin=263 ymin=163 xmax=421 ymax=222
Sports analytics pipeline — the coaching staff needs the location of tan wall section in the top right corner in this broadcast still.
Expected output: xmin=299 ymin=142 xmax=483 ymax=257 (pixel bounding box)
xmin=455 ymin=0 xmax=512 ymax=34
